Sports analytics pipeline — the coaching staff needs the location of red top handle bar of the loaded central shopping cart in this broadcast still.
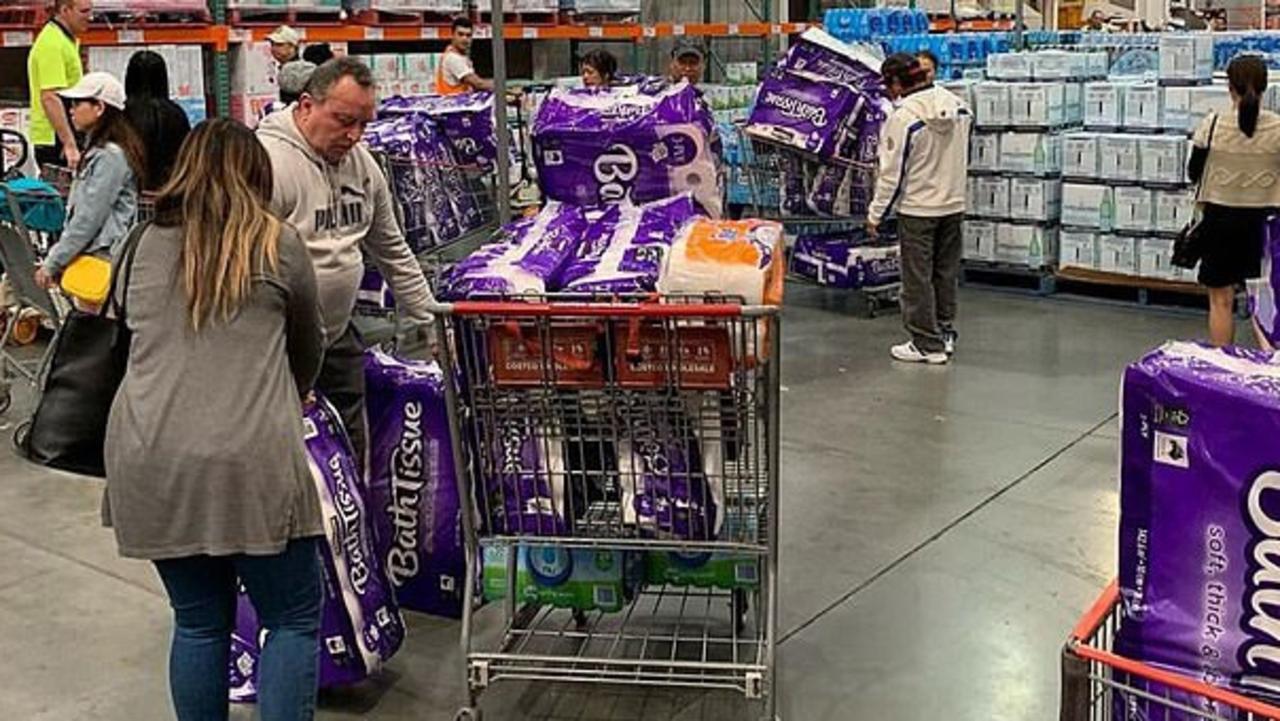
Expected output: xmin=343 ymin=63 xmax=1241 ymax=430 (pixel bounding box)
xmin=428 ymin=301 xmax=778 ymax=319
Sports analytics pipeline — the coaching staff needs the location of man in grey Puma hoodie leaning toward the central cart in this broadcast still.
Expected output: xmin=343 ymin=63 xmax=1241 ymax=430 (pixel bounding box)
xmin=257 ymin=58 xmax=433 ymax=457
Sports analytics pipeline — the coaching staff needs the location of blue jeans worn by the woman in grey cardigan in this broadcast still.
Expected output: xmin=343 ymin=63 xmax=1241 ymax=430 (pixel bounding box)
xmin=155 ymin=538 xmax=323 ymax=721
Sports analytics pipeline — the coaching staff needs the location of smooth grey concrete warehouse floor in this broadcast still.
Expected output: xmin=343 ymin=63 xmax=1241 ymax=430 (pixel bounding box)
xmin=0 ymin=287 xmax=1203 ymax=721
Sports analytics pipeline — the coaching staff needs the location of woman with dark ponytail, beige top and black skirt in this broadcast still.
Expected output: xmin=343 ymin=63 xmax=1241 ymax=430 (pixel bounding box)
xmin=1188 ymin=55 xmax=1280 ymax=346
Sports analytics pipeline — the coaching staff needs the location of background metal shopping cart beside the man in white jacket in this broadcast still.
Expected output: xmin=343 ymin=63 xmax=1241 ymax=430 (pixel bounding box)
xmin=724 ymin=123 xmax=901 ymax=316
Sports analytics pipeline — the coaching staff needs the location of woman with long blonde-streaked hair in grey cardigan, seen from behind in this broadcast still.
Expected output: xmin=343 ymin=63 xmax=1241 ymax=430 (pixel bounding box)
xmin=104 ymin=119 xmax=324 ymax=721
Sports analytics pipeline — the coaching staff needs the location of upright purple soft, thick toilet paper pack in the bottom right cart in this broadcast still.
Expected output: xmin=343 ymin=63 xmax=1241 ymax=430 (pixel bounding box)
xmin=1115 ymin=342 xmax=1280 ymax=721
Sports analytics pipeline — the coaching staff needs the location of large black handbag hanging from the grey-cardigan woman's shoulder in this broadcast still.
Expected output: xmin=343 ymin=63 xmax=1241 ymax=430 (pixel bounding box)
xmin=14 ymin=224 xmax=146 ymax=478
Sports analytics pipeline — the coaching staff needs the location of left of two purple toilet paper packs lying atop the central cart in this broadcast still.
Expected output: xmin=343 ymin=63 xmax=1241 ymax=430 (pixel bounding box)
xmin=440 ymin=201 xmax=588 ymax=300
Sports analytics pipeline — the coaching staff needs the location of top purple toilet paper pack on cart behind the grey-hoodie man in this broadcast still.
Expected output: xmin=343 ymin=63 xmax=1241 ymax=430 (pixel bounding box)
xmin=378 ymin=92 xmax=498 ymax=169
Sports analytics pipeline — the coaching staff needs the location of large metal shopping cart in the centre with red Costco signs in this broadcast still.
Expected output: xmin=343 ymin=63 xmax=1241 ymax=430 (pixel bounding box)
xmin=435 ymin=296 xmax=780 ymax=721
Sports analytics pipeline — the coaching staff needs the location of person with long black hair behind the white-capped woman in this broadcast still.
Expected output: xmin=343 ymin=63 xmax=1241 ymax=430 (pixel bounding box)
xmin=124 ymin=50 xmax=191 ymax=191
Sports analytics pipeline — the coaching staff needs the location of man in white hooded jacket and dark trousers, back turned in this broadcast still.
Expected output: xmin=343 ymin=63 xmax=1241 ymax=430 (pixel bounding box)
xmin=867 ymin=54 xmax=973 ymax=365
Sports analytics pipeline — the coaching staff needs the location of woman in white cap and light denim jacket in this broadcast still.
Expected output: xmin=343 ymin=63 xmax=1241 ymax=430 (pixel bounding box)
xmin=36 ymin=73 xmax=146 ymax=288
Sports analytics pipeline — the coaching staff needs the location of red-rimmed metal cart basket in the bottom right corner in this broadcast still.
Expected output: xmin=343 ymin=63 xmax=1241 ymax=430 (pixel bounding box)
xmin=1060 ymin=581 xmax=1280 ymax=721
